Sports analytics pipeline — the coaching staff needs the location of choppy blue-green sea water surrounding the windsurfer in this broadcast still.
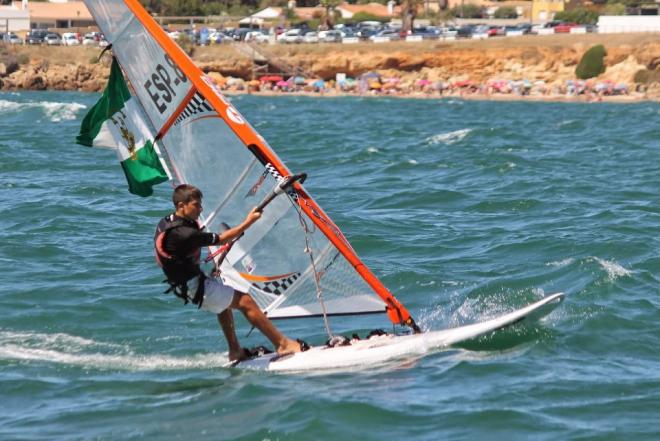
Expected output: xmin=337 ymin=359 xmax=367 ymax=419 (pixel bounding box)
xmin=0 ymin=92 xmax=660 ymax=441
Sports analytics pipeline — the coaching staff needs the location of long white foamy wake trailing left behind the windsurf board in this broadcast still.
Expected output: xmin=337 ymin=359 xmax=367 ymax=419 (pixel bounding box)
xmin=0 ymin=331 xmax=227 ymax=371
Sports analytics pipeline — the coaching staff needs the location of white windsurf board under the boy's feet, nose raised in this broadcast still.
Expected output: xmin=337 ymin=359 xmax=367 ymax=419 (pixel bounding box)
xmin=227 ymin=293 xmax=564 ymax=371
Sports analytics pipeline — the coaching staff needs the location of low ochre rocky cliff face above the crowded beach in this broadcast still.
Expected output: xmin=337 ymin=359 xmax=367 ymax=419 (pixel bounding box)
xmin=0 ymin=34 xmax=660 ymax=97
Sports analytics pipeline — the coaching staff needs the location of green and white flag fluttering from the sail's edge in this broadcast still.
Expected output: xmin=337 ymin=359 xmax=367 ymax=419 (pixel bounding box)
xmin=76 ymin=59 xmax=169 ymax=196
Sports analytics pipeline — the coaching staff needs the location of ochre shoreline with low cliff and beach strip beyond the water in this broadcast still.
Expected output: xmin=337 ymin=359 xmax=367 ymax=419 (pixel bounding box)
xmin=0 ymin=33 xmax=660 ymax=102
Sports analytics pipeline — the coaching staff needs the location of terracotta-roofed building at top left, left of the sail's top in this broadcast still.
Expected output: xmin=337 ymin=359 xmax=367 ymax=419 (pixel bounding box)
xmin=26 ymin=1 xmax=96 ymax=29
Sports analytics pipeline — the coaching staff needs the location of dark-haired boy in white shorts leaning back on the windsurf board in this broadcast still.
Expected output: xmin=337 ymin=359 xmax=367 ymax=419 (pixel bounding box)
xmin=154 ymin=184 xmax=308 ymax=361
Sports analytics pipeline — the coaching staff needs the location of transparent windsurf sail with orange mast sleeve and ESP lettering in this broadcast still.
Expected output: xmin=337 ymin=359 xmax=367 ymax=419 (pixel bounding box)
xmin=85 ymin=0 xmax=417 ymax=329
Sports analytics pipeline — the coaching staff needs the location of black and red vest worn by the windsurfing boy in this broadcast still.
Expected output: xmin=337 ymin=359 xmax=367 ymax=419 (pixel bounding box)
xmin=154 ymin=214 xmax=204 ymax=306
